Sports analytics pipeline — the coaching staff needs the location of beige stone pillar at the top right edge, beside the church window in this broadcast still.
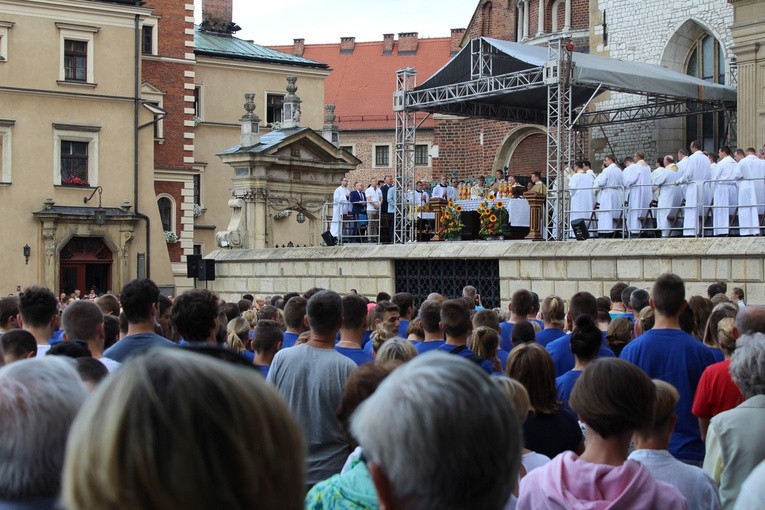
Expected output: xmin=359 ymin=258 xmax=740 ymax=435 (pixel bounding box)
xmin=728 ymin=0 xmax=765 ymax=148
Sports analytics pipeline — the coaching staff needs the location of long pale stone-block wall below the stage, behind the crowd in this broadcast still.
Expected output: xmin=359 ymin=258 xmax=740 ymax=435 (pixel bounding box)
xmin=209 ymin=238 xmax=765 ymax=306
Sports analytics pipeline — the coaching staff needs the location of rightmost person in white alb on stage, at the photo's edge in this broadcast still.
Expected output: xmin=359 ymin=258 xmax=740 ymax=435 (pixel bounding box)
xmin=735 ymin=147 xmax=765 ymax=236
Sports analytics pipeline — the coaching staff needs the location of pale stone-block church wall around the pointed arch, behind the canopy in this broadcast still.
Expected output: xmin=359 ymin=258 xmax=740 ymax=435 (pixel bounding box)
xmin=590 ymin=0 xmax=733 ymax=162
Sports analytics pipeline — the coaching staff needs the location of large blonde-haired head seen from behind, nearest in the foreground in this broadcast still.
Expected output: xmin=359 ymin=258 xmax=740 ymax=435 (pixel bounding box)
xmin=62 ymin=349 xmax=305 ymax=510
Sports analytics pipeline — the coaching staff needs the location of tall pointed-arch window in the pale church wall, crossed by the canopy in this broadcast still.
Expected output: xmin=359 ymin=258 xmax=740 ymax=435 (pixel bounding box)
xmin=685 ymin=34 xmax=725 ymax=151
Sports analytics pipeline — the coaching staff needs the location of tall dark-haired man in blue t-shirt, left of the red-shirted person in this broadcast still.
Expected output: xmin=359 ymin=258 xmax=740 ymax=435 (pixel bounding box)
xmin=621 ymin=273 xmax=714 ymax=463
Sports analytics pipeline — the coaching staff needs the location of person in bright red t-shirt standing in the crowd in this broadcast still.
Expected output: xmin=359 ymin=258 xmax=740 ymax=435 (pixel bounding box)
xmin=691 ymin=312 xmax=744 ymax=440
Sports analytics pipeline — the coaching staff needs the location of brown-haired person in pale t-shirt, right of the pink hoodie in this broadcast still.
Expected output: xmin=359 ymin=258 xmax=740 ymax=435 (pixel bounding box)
xmin=628 ymin=379 xmax=720 ymax=510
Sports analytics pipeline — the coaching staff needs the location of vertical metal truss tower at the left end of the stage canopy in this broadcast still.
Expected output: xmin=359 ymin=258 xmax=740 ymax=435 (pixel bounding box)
xmin=393 ymin=67 xmax=417 ymax=244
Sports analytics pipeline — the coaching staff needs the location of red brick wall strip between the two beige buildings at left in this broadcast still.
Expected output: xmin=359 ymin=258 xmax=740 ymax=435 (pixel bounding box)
xmin=142 ymin=0 xmax=194 ymax=169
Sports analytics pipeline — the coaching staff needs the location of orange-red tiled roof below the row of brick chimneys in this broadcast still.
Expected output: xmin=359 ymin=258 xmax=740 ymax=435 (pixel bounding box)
xmin=273 ymin=37 xmax=451 ymax=131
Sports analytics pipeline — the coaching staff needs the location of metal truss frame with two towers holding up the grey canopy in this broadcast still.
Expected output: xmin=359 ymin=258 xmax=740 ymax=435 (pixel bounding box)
xmin=393 ymin=36 xmax=736 ymax=243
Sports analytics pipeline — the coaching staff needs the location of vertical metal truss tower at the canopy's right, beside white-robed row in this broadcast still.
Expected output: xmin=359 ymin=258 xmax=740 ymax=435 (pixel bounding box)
xmin=543 ymin=38 xmax=573 ymax=240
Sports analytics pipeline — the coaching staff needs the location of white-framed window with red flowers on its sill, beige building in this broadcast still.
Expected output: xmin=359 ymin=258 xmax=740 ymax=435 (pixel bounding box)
xmin=53 ymin=124 xmax=101 ymax=187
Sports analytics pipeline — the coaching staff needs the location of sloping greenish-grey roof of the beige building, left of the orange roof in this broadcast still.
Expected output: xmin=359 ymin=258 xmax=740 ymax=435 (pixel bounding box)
xmin=194 ymin=27 xmax=328 ymax=69
